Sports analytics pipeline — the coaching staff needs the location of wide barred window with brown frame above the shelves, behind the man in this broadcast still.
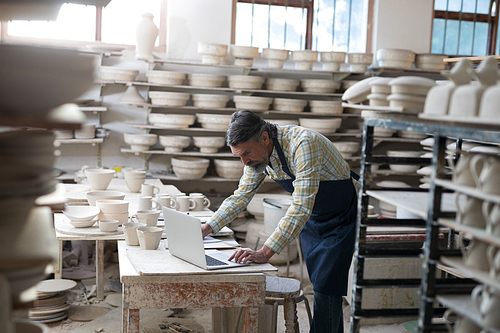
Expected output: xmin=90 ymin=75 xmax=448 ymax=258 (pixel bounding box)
xmin=233 ymin=0 xmax=369 ymax=52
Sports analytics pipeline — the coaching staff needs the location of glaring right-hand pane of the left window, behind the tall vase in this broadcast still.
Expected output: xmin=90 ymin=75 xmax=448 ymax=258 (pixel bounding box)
xmin=102 ymin=0 xmax=160 ymax=46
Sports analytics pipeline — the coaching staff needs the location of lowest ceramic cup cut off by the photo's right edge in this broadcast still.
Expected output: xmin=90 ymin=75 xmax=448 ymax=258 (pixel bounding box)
xmin=471 ymin=285 xmax=500 ymax=328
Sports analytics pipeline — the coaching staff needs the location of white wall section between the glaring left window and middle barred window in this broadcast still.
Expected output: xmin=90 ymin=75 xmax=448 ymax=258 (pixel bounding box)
xmin=167 ymin=0 xmax=232 ymax=60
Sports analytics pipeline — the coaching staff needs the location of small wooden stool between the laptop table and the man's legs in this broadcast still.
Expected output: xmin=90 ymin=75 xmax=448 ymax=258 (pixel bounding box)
xmin=265 ymin=276 xmax=312 ymax=333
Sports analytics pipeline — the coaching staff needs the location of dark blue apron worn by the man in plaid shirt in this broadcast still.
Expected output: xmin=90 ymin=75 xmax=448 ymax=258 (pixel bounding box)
xmin=273 ymin=138 xmax=359 ymax=296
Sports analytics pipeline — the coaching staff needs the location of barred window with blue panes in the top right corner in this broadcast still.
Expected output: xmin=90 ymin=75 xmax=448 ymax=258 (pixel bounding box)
xmin=431 ymin=0 xmax=499 ymax=56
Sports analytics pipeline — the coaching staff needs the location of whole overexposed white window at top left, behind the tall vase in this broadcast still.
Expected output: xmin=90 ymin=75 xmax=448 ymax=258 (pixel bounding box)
xmin=2 ymin=0 xmax=166 ymax=51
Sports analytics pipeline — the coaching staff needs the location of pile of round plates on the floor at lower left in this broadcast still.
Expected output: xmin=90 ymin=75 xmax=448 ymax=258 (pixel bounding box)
xmin=29 ymin=279 xmax=76 ymax=323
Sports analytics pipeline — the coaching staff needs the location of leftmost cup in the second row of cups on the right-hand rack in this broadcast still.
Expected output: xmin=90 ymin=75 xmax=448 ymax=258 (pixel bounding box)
xmin=455 ymin=193 xmax=486 ymax=229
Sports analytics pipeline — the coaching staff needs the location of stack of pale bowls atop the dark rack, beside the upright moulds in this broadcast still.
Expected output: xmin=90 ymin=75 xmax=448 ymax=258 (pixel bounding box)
xmin=387 ymin=76 xmax=436 ymax=113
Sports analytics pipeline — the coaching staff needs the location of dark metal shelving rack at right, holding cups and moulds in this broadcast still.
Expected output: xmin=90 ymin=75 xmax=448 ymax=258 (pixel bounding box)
xmin=351 ymin=112 xmax=500 ymax=333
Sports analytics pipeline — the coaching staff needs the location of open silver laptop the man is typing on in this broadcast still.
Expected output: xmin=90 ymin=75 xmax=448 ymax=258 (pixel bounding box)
xmin=163 ymin=207 xmax=248 ymax=269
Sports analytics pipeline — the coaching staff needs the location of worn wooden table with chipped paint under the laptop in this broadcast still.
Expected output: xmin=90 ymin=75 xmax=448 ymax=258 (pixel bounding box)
xmin=118 ymin=241 xmax=276 ymax=333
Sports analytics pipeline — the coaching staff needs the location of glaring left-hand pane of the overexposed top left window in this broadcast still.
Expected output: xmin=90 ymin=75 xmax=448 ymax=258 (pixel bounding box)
xmin=7 ymin=4 xmax=96 ymax=41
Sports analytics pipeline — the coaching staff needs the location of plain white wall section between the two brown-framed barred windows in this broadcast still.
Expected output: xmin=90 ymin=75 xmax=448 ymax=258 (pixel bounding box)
xmin=372 ymin=0 xmax=433 ymax=53
